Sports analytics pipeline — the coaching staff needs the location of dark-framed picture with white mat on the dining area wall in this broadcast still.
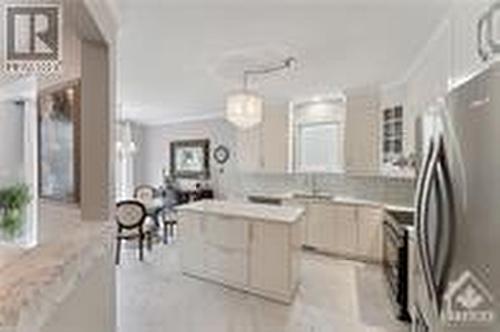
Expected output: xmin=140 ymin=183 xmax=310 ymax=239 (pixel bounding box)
xmin=170 ymin=139 xmax=210 ymax=180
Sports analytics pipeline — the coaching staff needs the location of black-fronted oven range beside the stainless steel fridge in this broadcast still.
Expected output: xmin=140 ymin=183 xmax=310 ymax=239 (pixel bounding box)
xmin=383 ymin=211 xmax=410 ymax=321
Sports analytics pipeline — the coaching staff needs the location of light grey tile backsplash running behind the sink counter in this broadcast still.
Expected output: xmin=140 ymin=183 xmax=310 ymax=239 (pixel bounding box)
xmin=231 ymin=173 xmax=415 ymax=206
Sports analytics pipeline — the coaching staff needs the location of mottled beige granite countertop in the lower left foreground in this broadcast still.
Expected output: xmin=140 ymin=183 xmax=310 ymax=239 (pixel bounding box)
xmin=0 ymin=222 xmax=114 ymax=332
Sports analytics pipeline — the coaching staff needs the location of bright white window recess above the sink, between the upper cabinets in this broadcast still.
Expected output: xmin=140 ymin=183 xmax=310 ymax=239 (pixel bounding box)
xmin=290 ymin=97 xmax=345 ymax=173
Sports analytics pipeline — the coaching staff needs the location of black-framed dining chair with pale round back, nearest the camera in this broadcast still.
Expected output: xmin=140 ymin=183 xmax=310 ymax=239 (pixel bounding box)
xmin=115 ymin=200 xmax=152 ymax=265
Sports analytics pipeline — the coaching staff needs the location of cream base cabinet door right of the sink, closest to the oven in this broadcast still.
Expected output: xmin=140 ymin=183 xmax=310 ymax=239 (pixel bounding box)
xmin=357 ymin=206 xmax=383 ymax=262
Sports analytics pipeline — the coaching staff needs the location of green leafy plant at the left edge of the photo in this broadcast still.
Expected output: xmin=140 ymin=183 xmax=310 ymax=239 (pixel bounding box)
xmin=0 ymin=184 xmax=31 ymax=239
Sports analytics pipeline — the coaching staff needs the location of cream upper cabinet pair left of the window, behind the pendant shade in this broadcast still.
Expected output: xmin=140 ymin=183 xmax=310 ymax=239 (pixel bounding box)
xmin=236 ymin=104 xmax=289 ymax=173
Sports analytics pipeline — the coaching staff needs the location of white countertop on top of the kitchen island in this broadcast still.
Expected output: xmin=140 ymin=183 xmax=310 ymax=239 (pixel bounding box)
xmin=177 ymin=200 xmax=304 ymax=223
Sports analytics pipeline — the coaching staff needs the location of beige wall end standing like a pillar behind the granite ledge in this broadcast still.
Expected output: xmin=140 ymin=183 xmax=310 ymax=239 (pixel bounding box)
xmin=80 ymin=41 xmax=110 ymax=220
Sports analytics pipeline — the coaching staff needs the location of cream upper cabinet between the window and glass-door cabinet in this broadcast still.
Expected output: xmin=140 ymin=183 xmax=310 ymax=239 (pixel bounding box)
xmin=344 ymin=87 xmax=380 ymax=175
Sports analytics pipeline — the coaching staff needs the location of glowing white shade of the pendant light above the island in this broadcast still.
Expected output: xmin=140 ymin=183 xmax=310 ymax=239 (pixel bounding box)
xmin=226 ymin=91 xmax=263 ymax=129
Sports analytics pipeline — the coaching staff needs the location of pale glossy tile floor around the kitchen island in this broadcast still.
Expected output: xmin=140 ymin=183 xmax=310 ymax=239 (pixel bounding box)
xmin=117 ymin=244 xmax=409 ymax=332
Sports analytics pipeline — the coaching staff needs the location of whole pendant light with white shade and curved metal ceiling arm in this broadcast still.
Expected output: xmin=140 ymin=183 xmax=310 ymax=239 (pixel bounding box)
xmin=226 ymin=57 xmax=296 ymax=130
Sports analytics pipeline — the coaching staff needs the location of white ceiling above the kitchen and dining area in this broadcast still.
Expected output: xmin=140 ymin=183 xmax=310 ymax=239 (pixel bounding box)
xmin=118 ymin=0 xmax=448 ymax=124
